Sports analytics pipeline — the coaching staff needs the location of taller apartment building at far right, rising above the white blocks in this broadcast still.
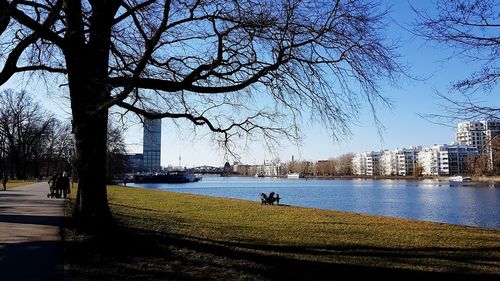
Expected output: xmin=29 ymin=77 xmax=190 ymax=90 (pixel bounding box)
xmin=456 ymin=119 xmax=500 ymax=169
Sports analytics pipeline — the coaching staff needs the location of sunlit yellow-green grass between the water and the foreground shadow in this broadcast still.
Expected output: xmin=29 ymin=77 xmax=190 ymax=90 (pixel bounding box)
xmin=108 ymin=186 xmax=500 ymax=274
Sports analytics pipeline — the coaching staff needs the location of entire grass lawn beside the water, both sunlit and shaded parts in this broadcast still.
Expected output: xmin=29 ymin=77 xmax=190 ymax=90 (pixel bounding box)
xmin=65 ymin=186 xmax=500 ymax=280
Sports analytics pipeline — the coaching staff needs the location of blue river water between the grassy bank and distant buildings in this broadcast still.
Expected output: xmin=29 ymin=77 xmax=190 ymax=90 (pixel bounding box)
xmin=129 ymin=177 xmax=500 ymax=229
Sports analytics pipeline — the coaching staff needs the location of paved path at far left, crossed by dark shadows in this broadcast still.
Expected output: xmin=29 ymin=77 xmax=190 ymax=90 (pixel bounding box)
xmin=0 ymin=182 xmax=64 ymax=281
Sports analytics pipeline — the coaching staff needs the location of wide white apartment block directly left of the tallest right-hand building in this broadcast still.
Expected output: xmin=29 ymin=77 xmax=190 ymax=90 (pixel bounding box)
xmin=417 ymin=144 xmax=479 ymax=176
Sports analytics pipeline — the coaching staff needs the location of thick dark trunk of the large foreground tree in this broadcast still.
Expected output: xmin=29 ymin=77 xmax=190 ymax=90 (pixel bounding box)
xmin=64 ymin=0 xmax=122 ymax=230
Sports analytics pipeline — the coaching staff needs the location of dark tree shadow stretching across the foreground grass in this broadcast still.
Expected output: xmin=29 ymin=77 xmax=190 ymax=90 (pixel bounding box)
xmin=65 ymin=220 xmax=500 ymax=280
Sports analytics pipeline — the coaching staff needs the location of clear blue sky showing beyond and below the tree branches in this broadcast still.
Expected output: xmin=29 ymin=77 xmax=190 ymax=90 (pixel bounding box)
xmin=1 ymin=0 xmax=500 ymax=166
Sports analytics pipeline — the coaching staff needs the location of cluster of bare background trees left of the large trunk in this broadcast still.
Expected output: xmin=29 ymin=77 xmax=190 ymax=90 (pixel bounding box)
xmin=0 ymin=90 xmax=74 ymax=180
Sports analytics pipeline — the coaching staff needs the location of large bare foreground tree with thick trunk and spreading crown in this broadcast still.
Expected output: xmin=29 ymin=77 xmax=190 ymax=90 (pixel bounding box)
xmin=0 ymin=0 xmax=401 ymax=225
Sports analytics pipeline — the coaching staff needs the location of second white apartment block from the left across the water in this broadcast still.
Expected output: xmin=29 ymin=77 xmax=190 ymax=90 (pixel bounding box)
xmin=380 ymin=146 xmax=422 ymax=176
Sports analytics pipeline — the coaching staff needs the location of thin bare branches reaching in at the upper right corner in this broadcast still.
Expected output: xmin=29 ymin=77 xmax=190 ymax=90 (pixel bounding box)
xmin=415 ymin=0 xmax=500 ymax=118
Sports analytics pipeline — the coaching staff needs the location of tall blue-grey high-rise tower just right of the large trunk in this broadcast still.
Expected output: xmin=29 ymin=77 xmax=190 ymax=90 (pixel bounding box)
xmin=142 ymin=119 xmax=161 ymax=172
